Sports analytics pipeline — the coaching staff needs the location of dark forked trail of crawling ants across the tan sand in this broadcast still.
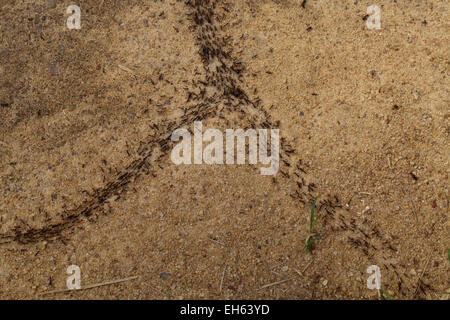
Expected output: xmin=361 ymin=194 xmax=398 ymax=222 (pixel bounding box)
xmin=0 ymin=0 xmax=411 ymax=300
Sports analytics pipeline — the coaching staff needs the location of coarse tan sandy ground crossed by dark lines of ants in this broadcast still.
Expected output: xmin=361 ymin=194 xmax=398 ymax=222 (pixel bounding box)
xmin=0 ymin=0 xmax=450 ymax=299
